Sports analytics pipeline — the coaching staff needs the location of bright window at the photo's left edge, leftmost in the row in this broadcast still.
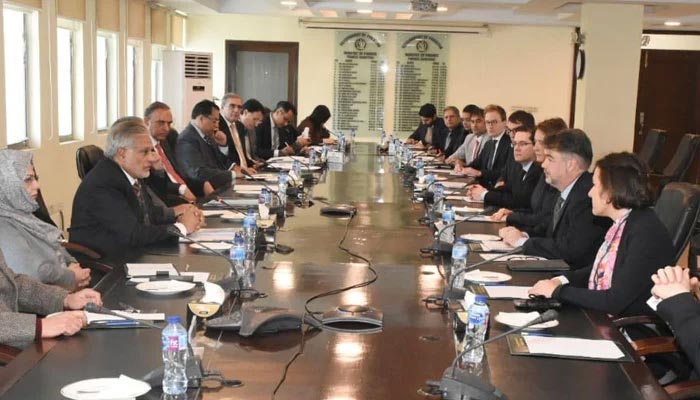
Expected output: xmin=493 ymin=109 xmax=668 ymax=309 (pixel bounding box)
xmin=3 ymin=6 xmax=32 ymax=147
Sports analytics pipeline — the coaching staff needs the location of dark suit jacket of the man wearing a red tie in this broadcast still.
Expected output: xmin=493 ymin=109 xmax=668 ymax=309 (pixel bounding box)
xmin=145 ymin=134 xmax=204 ymax=207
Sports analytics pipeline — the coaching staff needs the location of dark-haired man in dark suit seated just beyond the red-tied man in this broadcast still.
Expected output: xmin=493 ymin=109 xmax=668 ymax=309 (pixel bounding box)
xmin=176 ymin=100 xmax=236 ymax=189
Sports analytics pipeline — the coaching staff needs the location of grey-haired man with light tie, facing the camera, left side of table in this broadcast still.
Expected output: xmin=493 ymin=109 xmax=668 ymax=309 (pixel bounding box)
xmin=219 ymin=93 xmax=257 ymax=175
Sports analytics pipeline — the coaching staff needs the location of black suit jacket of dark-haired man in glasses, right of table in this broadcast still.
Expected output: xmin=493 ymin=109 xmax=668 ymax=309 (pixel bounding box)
xmin=484 ymin=162 xmax=542 ymax=210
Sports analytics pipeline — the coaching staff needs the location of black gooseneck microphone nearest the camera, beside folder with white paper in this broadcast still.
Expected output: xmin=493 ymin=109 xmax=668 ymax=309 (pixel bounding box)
xmin=428 ymin=310 xmax=559 ymax=400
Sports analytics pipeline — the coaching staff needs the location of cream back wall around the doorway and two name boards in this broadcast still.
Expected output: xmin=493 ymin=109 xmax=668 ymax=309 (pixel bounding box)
xmin=187 ymin=15 xmax=573 ymax=140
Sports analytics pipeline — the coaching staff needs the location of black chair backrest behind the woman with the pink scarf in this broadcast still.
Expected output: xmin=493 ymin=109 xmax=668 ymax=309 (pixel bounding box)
xmin=654 ymin=182 xmax=700 ymax=263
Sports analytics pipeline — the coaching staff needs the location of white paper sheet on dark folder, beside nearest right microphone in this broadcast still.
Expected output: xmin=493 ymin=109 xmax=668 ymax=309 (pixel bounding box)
xmin=523 ymin=336 xmax=625 ymax=360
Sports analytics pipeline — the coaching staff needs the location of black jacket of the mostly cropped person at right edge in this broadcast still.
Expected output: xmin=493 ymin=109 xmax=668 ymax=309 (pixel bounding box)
xmin=656 ymin=292 xmax=700 ymax=371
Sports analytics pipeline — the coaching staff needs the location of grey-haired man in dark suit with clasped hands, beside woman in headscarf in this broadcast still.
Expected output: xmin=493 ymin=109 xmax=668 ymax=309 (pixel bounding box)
xmin=69 ymin=117 xmax=203 ymax=260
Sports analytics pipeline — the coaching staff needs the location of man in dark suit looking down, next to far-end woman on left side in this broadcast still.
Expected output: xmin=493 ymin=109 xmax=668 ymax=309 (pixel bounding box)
xmin=255 ymin=101 xmax=311 ymax=160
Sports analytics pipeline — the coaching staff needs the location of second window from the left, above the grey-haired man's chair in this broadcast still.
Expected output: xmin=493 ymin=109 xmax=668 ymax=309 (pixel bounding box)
xmin=56 ymin=19 xmax=84 ymax=141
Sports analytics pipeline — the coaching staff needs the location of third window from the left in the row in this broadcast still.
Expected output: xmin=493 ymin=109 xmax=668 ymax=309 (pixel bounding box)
xmin=95 ymin=32 xmax=117 ymax=131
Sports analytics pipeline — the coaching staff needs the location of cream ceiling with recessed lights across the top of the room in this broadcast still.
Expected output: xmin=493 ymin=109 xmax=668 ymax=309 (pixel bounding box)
xmin=154 ymin=0 xmax=700 ymax=31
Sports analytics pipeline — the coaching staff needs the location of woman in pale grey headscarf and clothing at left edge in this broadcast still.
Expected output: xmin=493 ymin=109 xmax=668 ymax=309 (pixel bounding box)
xmin=0 ymin=150 xmax=90 ymax=290
